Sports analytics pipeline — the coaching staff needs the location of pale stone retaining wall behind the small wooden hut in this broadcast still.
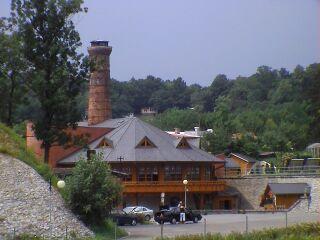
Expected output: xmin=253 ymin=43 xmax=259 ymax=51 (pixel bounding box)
xmin=226 ymin=176 xmax=320 ymax=212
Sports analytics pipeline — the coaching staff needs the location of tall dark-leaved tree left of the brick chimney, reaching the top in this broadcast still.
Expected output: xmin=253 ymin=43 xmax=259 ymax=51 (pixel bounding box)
xmin=11 ymin=0 xmax=87 ymax=162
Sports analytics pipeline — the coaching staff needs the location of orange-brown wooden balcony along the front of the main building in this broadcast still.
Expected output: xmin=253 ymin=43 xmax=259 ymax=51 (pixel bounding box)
xmin=123 ymin=181 xmax=226 ymax=193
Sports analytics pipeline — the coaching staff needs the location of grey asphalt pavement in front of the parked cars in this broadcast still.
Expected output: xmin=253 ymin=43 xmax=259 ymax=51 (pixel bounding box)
xmin=123 ymin=213 xmax=320 ymax=240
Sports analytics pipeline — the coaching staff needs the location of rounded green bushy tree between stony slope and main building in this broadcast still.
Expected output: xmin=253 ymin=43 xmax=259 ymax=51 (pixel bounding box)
xmin=66 ymin=154 xmax=122 ymax=224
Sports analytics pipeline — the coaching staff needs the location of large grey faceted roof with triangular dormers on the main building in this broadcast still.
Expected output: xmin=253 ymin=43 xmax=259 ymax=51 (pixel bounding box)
xmin=59 ymin=117 xmax=220 ymax=164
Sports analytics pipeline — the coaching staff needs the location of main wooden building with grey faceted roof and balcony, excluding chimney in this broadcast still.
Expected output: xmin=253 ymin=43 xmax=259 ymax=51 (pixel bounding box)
xmin=53 ymin=117 xmax=226 ymax=208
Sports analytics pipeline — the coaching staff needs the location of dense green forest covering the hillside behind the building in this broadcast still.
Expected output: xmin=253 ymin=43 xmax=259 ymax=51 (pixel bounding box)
xmin=0 ymin=57 xmax=320 ymax=156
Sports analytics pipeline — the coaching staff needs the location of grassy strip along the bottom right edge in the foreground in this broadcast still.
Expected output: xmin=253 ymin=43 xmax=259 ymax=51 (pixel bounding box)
xmin=156 ymin=222 xmax=320 ymax=240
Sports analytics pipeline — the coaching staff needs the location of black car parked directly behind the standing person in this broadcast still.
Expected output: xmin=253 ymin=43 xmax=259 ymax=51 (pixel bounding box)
xmin=154 ymin=207 xmax=202 ymax=224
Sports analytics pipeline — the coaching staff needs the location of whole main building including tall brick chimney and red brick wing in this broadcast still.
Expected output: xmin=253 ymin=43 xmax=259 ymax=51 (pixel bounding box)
xmin=27 ymin=40 xmax=234 ymax=209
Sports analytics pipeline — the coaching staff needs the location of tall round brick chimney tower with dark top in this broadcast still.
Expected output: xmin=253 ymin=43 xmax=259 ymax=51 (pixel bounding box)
xmin=88 ymin=40 xmax=112 ymax=125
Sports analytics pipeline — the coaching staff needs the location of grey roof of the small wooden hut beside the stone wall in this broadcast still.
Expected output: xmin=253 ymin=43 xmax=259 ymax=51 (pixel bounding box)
xmin=268 ymin=183 xmax=309 ymax=194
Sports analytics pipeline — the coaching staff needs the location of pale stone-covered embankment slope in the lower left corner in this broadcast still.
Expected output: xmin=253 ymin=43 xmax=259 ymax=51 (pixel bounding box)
xmin=0 ymin=154 xmax=93 ymax=239
